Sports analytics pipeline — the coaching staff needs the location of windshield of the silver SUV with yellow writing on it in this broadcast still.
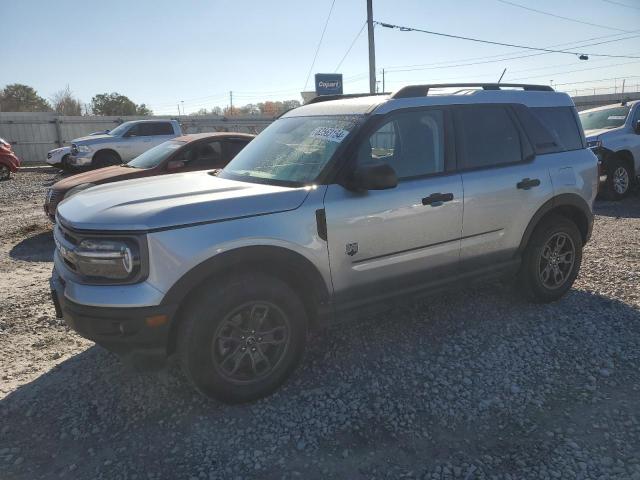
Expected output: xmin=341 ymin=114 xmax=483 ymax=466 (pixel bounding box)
xmin=219 ymin=115 xmax=362 ymax=185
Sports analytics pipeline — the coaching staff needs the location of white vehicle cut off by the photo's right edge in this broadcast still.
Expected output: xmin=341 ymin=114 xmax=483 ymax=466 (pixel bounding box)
xmin=580 ymin=100 xmax=640 ymax=200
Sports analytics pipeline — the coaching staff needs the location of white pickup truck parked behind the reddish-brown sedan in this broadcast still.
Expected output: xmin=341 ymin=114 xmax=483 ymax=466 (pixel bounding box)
xmin=68 ymin=120 xmax=182 ymax=169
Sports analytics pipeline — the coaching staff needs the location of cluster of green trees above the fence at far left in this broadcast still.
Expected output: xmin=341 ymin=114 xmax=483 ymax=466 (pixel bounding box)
xmin=0 ymin=83 xmax=153 ymax=116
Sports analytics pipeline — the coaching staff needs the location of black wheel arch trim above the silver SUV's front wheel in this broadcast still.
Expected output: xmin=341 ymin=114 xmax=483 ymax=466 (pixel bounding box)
xmin=162 ymin=245 xmax=330 ymax=354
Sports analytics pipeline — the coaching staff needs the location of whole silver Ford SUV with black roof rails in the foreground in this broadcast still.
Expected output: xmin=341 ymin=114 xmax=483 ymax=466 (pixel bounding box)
xmin=51 ymin=84 xmax=598 ymax=402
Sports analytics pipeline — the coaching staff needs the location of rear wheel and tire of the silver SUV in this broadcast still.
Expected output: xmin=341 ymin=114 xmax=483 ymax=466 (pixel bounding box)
xmin=519 ymin=215 xmax=582 ymax=303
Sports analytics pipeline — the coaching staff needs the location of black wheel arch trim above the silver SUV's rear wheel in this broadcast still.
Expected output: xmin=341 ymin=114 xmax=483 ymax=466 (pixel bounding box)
xmin=517 ymin=193 xmax=593 ymax=254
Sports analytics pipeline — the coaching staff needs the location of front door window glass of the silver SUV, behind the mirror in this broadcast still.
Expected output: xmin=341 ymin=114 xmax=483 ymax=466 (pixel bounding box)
xmin=357 ymin=110 xmax=445 ymax=179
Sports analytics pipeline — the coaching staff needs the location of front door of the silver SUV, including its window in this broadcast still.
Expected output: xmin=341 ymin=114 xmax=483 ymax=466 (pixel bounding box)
xmin=324 ymin=108 xmax=463 ymax=307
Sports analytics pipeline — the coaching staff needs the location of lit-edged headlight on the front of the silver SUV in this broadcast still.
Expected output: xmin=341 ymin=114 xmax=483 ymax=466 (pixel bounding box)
xmin=74 ymin=238 xmax=140 ymax=281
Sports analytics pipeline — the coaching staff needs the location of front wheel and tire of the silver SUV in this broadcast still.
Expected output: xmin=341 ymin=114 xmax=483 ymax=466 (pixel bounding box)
xmin=177 ymin=273 xmax=307 ymax=403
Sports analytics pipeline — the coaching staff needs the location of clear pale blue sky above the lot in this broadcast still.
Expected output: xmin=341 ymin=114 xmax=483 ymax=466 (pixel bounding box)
xmin=0 ymin=0 xmax=640 ymax=115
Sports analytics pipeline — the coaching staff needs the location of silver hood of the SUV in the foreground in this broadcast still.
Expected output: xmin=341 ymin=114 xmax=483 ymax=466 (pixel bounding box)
xmin=58 ymin=172 xmax=309 ymax=231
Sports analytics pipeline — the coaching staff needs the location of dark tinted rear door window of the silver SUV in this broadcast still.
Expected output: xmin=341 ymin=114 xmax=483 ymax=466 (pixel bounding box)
xmin=456 ymin=105 xmax=522 ymax=168
